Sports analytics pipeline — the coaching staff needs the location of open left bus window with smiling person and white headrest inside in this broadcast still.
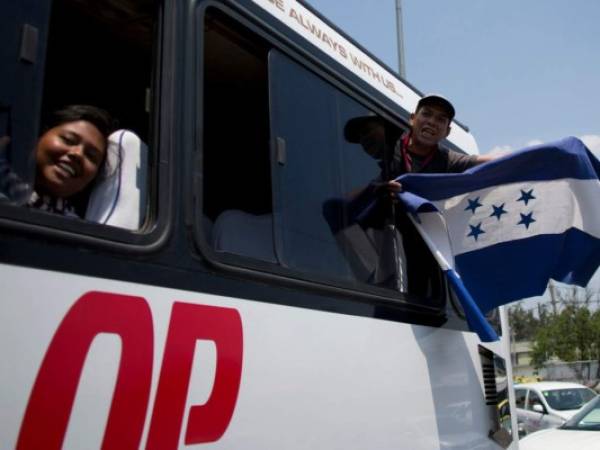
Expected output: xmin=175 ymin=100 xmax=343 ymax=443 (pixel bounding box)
xmin=0 ymin=0 xmax=160 ymax=232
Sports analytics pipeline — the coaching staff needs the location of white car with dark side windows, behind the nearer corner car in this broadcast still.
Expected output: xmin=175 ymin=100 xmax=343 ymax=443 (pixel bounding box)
xmin=515 ymin=381 xmax=600 ymax=436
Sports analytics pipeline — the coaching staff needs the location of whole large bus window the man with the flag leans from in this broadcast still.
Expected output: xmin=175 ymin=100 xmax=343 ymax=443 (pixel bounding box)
xmin=202 ymin=10 xmax=443 ymax=307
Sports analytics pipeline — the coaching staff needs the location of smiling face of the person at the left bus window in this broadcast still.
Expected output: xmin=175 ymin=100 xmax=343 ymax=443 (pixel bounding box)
xmin=35 ymin=120 xmax=106 ymax=198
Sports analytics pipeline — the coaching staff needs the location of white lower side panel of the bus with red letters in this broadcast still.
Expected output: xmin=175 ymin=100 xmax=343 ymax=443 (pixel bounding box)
xmin=0 ymin=265 xmax=508 ymax=450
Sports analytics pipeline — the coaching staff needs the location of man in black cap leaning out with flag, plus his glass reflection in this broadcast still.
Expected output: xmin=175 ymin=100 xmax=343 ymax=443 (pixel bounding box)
xmin=344 ymin=94 xmax=492 ymax=298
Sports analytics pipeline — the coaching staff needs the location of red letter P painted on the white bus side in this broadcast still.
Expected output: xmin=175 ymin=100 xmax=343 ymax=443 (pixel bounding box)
xmin=146 ymin=302 xmax=243 ymax=450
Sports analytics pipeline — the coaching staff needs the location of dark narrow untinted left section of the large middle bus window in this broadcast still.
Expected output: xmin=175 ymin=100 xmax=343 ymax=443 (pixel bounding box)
xmin=203 ymin=9 xmax=276 ymax=263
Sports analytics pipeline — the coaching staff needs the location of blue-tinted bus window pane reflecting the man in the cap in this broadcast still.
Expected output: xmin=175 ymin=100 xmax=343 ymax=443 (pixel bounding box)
xmin=269 ymin=47 xmax=443 ymax=306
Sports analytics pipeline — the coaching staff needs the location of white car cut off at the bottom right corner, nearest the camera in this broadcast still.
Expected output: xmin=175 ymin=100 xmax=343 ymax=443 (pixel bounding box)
xmin=519 ymin=397 xmax=600 ymax=450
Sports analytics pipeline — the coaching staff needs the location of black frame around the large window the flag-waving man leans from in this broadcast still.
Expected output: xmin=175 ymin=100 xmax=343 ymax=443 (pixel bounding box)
xmin=190 ymin=0 xmax=454 ymax=318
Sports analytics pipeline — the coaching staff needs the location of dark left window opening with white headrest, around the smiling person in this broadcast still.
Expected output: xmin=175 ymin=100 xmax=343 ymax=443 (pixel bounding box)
xmin=0 ymin=0 xmax=157 ymax=229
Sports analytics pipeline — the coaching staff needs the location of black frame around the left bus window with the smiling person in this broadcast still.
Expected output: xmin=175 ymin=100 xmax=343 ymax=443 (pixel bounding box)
xmin=0 ymin=0 xmax=176 ymax=254
